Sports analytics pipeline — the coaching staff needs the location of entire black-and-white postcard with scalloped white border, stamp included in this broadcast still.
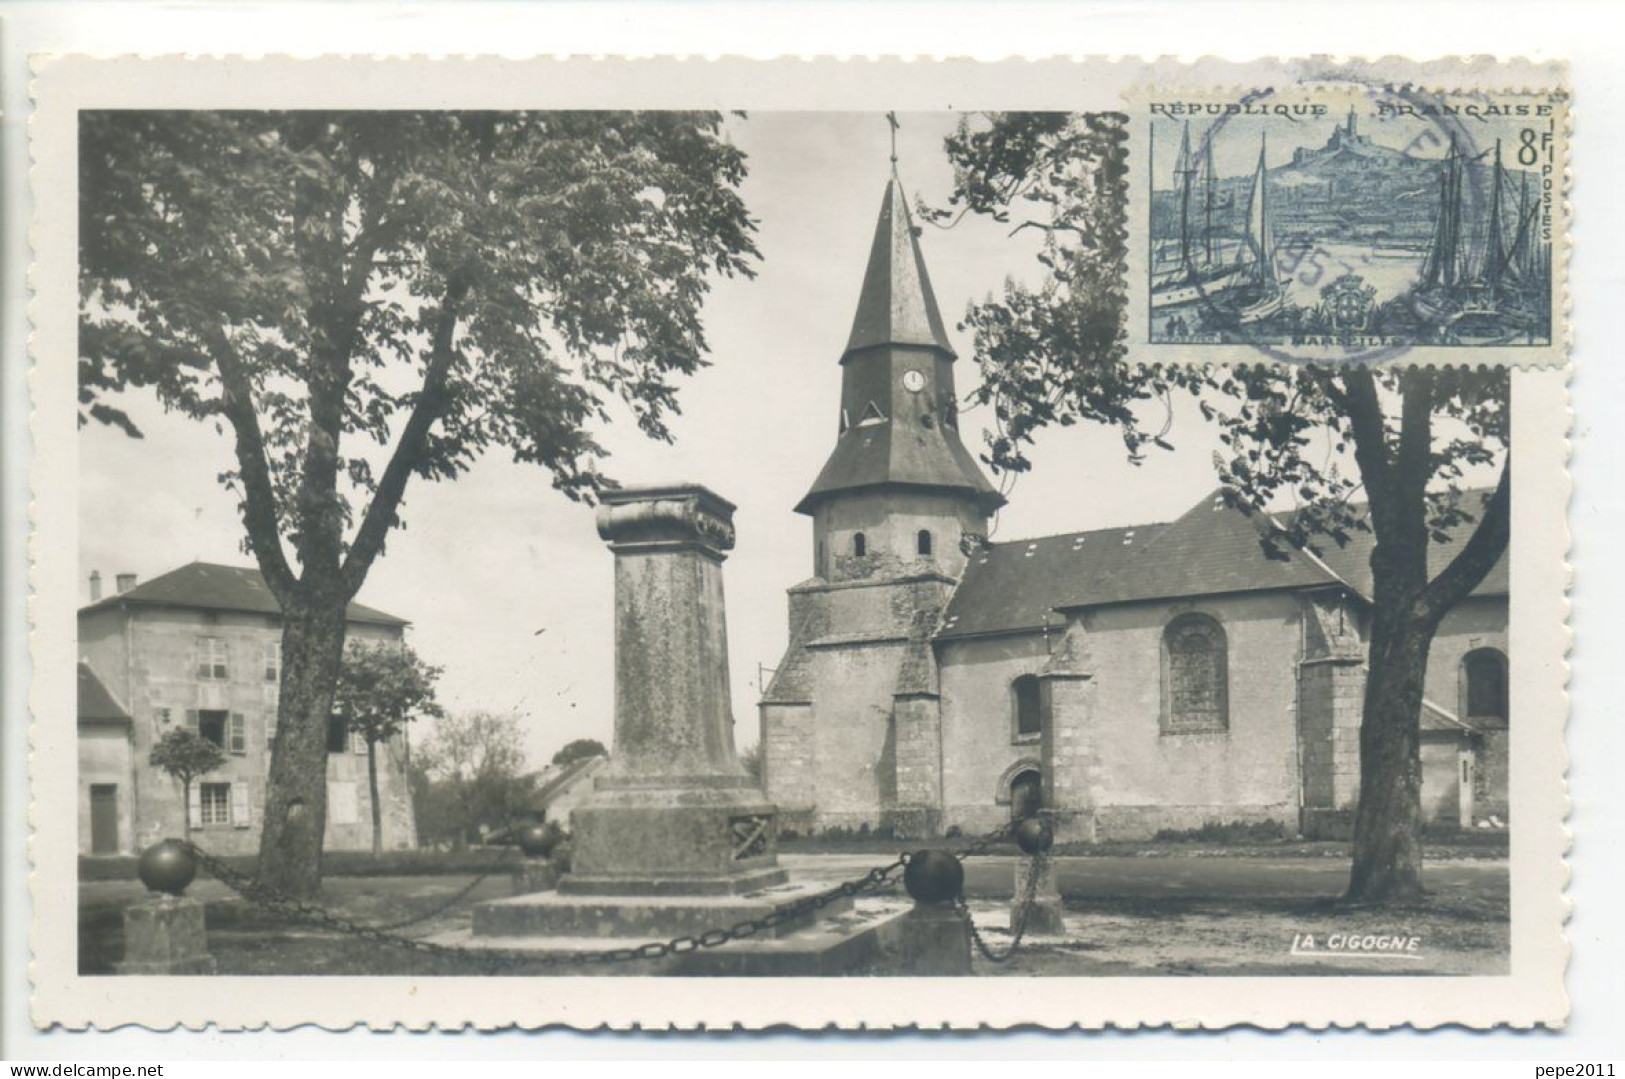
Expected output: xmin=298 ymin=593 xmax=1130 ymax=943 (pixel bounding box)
xmin=29 ymin=57 xmax=1568 ymax=1029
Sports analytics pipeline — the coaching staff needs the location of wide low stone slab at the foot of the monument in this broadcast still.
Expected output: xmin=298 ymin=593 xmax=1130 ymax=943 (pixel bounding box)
xmin=473 ymin=869 xmax=852 ymax=944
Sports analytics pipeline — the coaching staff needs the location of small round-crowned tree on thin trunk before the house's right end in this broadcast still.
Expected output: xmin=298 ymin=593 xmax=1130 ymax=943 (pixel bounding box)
xmin=333 ymin=640 xmax=442 ymax=855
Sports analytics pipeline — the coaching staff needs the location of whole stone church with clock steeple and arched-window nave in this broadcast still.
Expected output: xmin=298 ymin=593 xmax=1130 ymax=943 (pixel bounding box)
xmin=761 ymin=177 xmax=1508 ymax=842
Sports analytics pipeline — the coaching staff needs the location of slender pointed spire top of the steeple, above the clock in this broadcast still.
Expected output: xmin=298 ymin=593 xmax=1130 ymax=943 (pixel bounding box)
xmin=847 ymin=172 xmax=954 ymax=356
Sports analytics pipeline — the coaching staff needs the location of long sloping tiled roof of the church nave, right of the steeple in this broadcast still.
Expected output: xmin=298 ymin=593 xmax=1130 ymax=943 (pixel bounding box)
xmin=938 ymin=491 xmax=1506 ymax=639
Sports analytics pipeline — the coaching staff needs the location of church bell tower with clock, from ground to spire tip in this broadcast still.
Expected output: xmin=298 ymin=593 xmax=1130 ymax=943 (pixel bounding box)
xmin=761 ymin=172 xmax=1004 ymax=837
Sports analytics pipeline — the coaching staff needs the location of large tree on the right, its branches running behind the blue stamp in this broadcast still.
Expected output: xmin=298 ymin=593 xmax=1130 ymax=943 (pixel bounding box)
xmin=933 ymin=114 xmax=1511 ymax=902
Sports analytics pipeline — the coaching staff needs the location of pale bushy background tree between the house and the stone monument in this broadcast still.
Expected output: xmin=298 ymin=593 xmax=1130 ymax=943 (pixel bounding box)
xmin=418 ymin=712 xmax=531 ymax=847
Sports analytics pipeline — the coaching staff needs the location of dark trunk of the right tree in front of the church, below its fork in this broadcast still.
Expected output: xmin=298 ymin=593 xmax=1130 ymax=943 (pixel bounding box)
xmin=1349 ymin=611 xmax=1433 ymax=904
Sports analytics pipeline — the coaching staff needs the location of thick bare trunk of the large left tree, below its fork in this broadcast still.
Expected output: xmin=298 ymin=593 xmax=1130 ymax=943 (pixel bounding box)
xmin=260 ymin=598 xmax=346 ymax=899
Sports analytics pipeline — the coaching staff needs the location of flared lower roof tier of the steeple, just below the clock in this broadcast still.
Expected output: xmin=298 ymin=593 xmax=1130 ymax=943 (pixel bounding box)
xmin=796 ymin=412 xmax=1004 ymax=514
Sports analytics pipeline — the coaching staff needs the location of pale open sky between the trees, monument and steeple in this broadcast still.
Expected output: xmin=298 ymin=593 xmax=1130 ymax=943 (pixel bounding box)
xmin=78 ymin=114 xmax=1261 ymax=767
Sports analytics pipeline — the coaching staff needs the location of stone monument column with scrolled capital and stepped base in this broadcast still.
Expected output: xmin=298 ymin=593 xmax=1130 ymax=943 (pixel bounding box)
xmin=470 ymin=484 xmax=890 ymax=973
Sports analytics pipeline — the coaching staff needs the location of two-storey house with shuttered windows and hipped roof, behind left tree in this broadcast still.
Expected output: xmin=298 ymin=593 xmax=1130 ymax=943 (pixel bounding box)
xmin=78 ymin=562 xmax=418 ymax=855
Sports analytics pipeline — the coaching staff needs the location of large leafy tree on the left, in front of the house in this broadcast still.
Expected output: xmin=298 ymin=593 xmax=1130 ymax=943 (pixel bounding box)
xmin=80 ymin=111 xmax=756 ymax=895
